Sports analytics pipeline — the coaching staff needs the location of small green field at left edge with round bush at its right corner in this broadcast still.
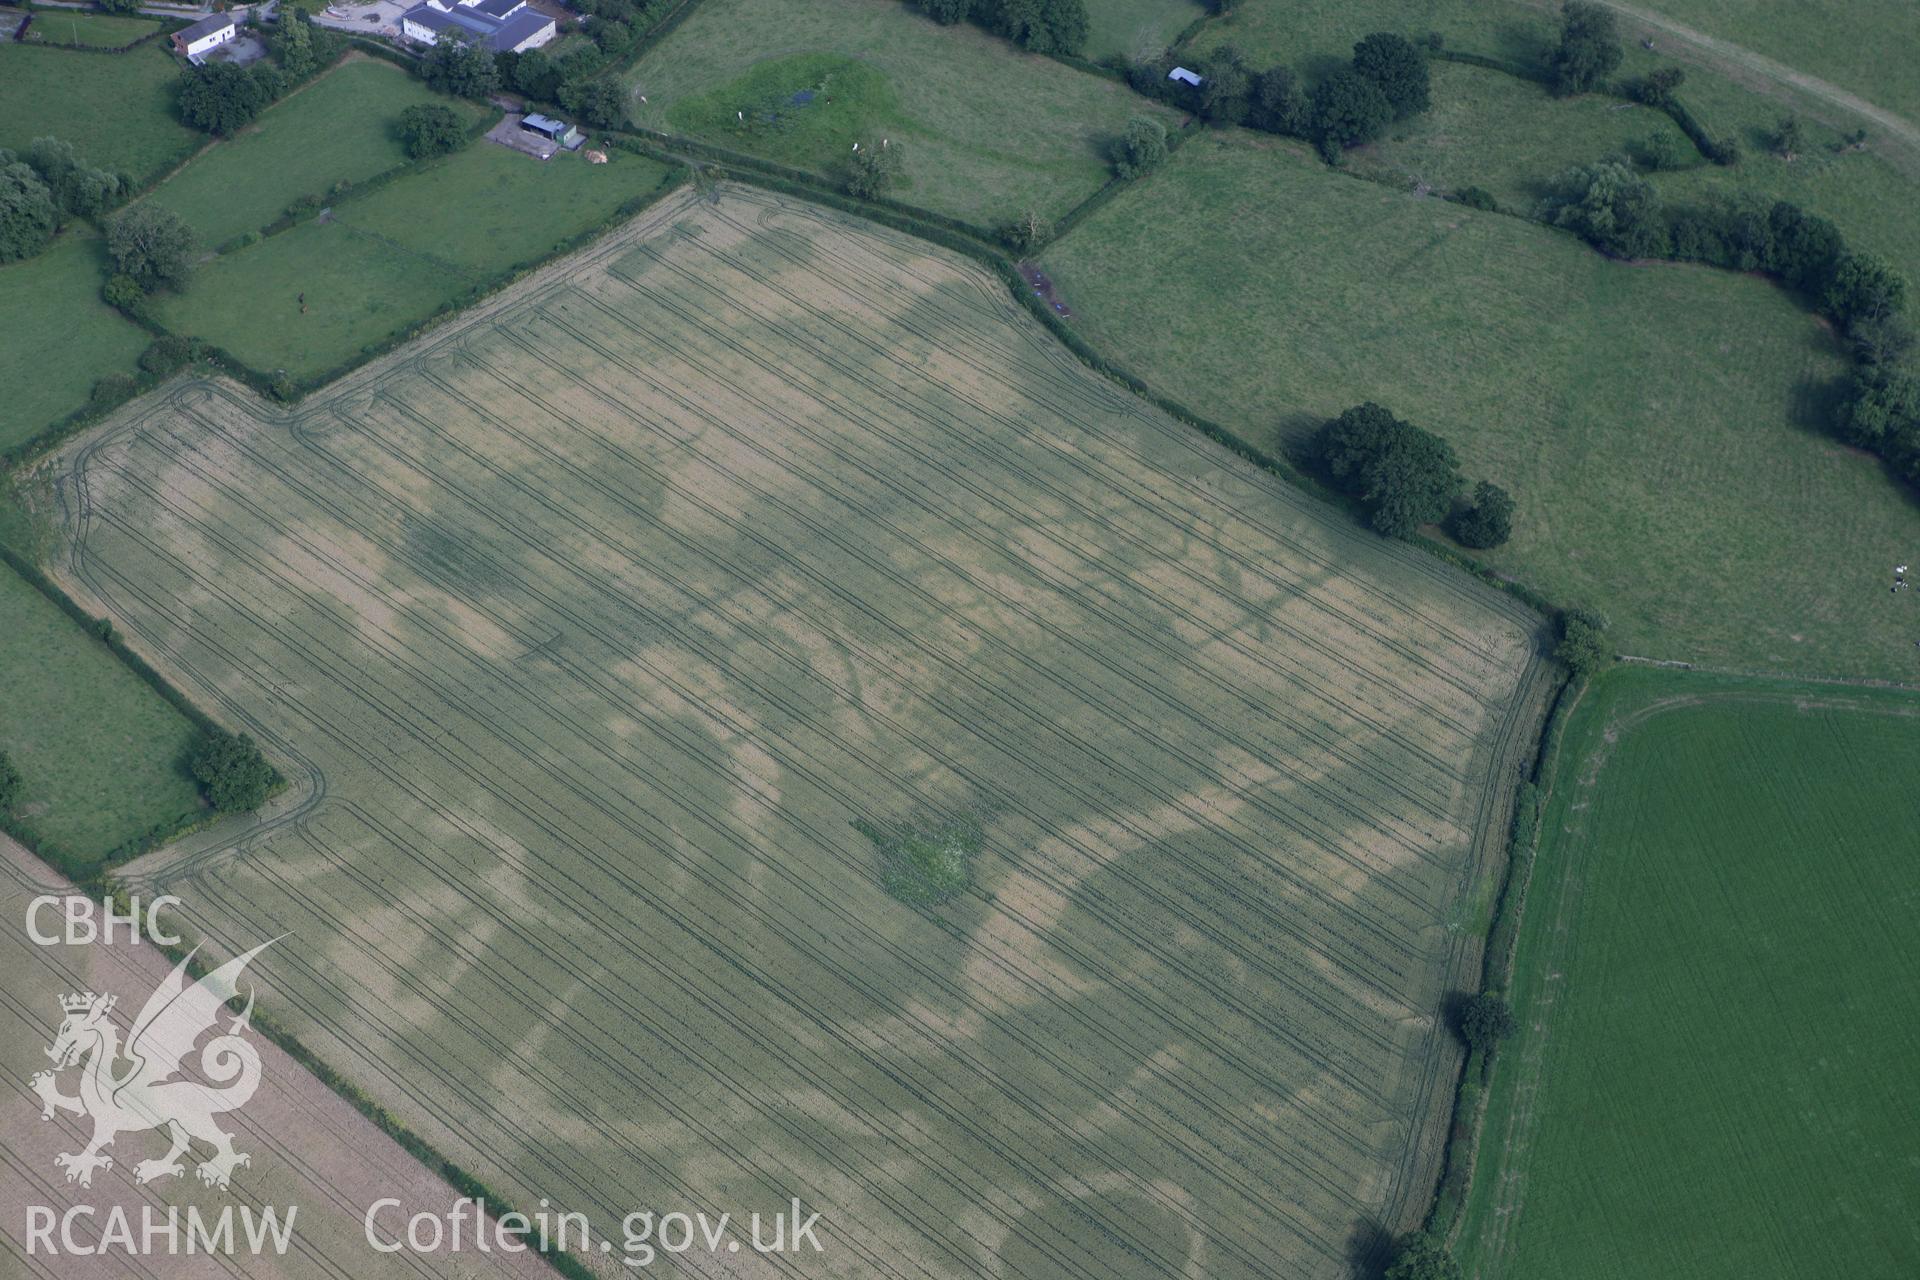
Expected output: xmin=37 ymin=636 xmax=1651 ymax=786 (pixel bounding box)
xmin=0 ymin=564 xmax=202 ymax=875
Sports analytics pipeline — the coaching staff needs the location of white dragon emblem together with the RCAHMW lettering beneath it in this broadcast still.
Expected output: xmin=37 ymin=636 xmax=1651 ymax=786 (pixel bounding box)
xmin=27 ymin=921 xmax=298 ymax=1255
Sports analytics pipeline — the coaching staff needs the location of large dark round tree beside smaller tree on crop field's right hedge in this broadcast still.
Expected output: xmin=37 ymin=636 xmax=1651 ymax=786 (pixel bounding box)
xmin=1315 ymin=403 xmax=1459 ymax=537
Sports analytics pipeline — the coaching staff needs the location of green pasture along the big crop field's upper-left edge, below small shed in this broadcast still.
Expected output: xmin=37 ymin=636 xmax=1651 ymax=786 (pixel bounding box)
xmin=157 ymin=142 xmax=683 ymax=378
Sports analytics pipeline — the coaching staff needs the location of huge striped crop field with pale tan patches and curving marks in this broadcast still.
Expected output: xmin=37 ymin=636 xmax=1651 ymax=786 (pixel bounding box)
xmin=41 ymin=190 xmax=1544 ymax=1280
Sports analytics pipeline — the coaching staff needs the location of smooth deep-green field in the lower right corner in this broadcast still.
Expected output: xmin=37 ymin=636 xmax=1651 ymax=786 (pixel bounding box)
xmin=1459 ymin=667 xmax=1920 ymax=1280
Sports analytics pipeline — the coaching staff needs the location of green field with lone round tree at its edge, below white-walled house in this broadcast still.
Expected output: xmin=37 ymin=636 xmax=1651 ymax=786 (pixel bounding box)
xmin=150 ymin=56 xmax=490 ymax=249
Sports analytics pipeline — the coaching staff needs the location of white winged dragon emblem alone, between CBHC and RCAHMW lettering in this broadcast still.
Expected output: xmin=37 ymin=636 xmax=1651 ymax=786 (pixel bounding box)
xmin=31 ymin=938 xmax=278 ymax=1190
